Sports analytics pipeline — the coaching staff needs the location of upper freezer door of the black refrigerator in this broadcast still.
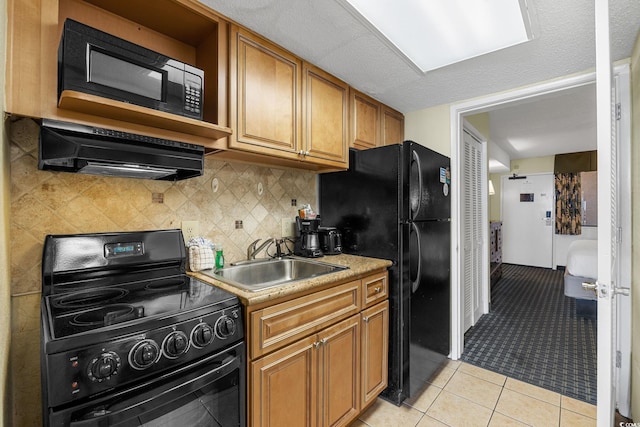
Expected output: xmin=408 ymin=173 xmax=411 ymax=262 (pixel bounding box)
xmin=404 ymin=142 xmax=451 ymax=221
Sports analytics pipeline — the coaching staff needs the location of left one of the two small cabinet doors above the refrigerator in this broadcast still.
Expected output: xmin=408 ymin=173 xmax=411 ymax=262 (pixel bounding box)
xmin=350 ymin=89 xmax=381 ymax=149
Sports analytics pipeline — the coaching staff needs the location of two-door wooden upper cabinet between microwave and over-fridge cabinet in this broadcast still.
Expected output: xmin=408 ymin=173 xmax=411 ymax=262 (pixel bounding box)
xmin=221 ymin=26 xmax=348 ymax=170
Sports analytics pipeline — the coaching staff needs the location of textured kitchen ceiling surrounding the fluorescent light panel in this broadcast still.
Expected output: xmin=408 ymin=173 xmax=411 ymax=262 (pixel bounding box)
xmin=200 ymin=0 xmax=640 ymax=113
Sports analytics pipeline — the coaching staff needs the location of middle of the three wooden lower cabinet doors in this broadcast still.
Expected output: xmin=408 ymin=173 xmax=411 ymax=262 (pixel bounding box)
xmin=318 ymin=315 xmax=360 ymax=426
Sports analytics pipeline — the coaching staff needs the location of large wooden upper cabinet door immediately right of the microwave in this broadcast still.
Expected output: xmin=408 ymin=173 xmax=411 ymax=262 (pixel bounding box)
xmin=229 ymin=26 xmax=302 ymax=155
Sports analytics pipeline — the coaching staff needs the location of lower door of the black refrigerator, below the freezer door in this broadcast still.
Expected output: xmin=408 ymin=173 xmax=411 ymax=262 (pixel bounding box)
xmin=406 ymin=221 xmax=451 ymax=396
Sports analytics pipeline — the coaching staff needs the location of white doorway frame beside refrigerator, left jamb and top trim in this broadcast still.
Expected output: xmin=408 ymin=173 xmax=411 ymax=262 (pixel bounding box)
xmin=450 ymin=72 xmax=596 ymax=360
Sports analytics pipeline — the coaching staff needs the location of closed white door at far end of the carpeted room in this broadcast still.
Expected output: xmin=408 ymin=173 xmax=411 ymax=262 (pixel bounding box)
xmin=501 ymin=174 xmax=554 ymax=268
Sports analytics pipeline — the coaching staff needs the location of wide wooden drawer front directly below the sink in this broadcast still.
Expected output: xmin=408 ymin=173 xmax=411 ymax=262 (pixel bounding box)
xmin=250 ymin=280 xmax=360 ymax=358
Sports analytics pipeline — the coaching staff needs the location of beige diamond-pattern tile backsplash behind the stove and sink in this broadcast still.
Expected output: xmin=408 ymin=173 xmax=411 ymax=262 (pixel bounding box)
xmin=8 ymin=118 xmax=316 ymax=295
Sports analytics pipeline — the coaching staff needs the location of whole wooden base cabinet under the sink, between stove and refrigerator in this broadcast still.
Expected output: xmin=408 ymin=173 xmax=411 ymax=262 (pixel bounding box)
xmin=247 ymin=273 xmax=389 ymax=427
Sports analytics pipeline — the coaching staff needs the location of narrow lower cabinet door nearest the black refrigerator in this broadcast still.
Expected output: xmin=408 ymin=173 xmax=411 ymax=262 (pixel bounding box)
xmin=361 ymin=301 xmax=389 ymax=408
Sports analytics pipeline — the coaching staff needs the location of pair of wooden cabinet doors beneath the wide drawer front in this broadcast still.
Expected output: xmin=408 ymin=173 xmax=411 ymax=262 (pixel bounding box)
xmin=249 ymin=315 xmax=360 ymax=427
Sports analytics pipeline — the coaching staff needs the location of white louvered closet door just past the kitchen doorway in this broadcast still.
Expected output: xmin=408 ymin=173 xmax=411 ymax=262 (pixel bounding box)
xmin=461 ymin=130 xmax=488 ymax=331
